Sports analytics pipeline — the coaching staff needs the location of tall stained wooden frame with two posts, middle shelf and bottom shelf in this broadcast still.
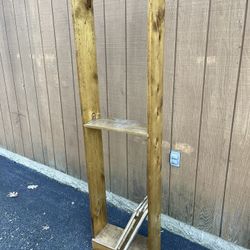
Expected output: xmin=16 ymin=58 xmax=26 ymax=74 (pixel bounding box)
xmin=72 ymin=0 xmax=165 ymax=250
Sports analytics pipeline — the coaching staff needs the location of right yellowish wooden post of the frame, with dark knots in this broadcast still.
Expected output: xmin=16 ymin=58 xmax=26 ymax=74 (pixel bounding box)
xmin=147 ymin=0 xmax=165 ymax=250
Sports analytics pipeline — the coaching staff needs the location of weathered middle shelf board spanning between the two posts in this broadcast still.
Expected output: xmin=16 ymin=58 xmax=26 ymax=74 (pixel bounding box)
xmin=84 ymin=119 xmax=148 ymax=137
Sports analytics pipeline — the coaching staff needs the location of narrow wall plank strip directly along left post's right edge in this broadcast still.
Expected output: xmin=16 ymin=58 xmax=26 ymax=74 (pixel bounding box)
xmin=94 ymin=1 xmax=111 ymax=191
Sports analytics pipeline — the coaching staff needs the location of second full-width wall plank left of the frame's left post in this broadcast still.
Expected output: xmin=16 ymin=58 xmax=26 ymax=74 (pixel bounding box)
xmin=38 ymin=0 xmax=67 ymax=172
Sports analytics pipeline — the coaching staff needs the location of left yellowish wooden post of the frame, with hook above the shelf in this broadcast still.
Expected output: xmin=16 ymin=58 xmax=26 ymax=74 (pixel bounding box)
xmin=72 ymin=0 xmax=107 ymax=236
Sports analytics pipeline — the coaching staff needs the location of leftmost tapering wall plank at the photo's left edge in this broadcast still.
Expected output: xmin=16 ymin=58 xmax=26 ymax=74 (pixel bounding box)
xmin=0 ymin=54 xmax=16 ymax=152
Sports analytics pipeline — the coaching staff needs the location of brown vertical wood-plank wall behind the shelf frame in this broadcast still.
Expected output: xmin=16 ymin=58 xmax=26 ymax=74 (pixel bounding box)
xmin=0 ymin=0 xmax=250 ymax=247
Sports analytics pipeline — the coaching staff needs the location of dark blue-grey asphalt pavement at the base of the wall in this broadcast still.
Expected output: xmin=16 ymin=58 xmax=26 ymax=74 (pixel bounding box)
xmin=0 ymin=156 xmax=208 ymax=250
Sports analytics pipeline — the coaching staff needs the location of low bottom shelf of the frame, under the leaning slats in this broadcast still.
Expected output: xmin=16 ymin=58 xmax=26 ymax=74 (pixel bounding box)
xmin=92 ymin=224 xmax=147 ymax=250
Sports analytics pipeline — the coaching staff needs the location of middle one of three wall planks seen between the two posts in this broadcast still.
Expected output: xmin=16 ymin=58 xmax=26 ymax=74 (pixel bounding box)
xmin=105 ymin=0 xmax=128 ymax=197
